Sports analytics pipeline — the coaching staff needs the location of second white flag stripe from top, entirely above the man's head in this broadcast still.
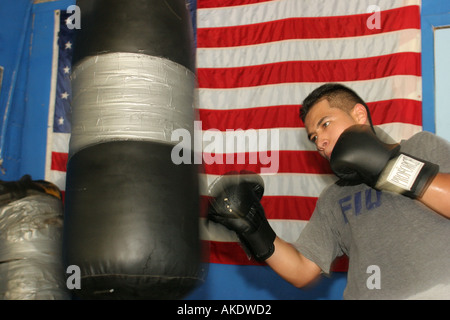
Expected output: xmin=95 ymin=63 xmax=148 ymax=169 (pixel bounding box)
xmin=197 ymin=29 xmax=421 ymax=68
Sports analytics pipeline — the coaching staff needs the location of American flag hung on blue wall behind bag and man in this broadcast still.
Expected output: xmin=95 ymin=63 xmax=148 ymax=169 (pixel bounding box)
xmin=46 ymin=0 xmax=422 ymax=276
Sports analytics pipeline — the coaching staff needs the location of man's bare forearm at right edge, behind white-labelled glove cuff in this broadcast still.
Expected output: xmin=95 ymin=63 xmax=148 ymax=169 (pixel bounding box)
xmin=418 ymin=173 xmax=450 ymax=218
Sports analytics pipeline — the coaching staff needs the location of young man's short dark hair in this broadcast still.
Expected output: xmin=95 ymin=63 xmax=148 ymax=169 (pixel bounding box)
xmin=300 ymin=83 xmax=373 ymax=128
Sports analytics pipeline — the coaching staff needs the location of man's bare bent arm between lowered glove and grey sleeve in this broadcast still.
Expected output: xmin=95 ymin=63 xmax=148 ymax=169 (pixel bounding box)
xmin=266 ymin=237 xmax=321 ymax=288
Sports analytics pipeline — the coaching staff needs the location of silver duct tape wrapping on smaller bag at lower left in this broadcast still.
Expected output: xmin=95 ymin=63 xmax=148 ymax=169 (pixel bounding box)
xmin=0 ymin=195 xmax=70 ymax=300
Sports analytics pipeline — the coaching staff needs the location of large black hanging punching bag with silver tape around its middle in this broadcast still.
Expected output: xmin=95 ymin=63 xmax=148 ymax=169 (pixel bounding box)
xmin=63 ymin=0 xmax=205 ymax=299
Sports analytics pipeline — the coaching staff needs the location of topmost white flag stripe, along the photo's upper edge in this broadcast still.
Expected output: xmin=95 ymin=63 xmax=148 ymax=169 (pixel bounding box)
xmin=197 ymin=0 xmax=420 ymax=28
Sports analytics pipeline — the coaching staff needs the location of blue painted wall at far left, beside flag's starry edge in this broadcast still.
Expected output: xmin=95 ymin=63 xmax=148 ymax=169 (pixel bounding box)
xmin=0 ymin=0 xmax=75 ymax=180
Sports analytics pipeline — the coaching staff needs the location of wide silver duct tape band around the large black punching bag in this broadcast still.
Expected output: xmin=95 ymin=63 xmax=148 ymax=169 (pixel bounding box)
xmin=69 ymin=52 xmax=196 ymax=156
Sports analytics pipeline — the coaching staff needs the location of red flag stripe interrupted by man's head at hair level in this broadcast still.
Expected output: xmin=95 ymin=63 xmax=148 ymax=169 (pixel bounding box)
xmin=198 ymin=99 xmax=422 ymax=131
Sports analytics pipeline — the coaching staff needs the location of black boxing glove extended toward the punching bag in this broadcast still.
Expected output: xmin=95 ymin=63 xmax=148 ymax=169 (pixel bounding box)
xmin=208 ymin=174 xmax=276 ymax=261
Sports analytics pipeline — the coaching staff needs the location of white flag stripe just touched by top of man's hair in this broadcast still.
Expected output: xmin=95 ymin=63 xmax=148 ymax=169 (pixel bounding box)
xmin=198 ymin=75 xmax=422 ymax=110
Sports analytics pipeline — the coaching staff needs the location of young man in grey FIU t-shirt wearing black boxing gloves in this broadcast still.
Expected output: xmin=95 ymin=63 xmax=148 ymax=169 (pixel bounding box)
xmin=209 ymin=83 xmax=450 ymax=299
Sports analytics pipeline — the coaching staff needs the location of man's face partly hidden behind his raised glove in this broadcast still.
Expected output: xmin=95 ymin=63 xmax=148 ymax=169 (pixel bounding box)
xmin=305 ymin=99 xmax=359 ymax=161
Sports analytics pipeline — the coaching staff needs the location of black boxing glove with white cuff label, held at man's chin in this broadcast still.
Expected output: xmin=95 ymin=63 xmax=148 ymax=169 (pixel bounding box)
xmin=330 ymin=125 xmax=439 ymax=199
